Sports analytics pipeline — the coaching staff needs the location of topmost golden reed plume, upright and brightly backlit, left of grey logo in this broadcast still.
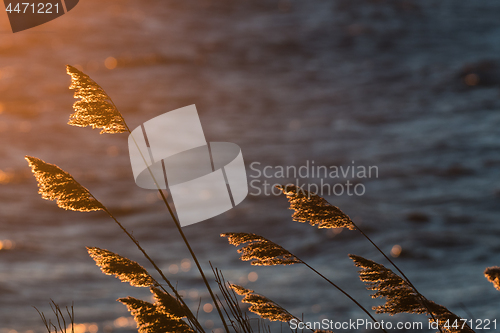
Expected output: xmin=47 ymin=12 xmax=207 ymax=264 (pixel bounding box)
xmin=66 ymin=65 xmax=128 ymax=134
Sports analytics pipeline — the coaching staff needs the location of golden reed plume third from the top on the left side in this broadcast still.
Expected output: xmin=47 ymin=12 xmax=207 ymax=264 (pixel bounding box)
xmin=87 ymin=247 xmax=157 ymax=287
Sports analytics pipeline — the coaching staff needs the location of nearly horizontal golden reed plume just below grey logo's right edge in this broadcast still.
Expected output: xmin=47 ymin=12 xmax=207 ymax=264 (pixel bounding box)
xmin=221 ymin=232 xmax=302 ymax=266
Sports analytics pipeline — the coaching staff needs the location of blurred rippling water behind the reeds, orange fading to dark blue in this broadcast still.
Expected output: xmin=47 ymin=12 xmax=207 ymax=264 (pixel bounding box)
xmin=0 ymin=0 xmax=500 ymax=333
